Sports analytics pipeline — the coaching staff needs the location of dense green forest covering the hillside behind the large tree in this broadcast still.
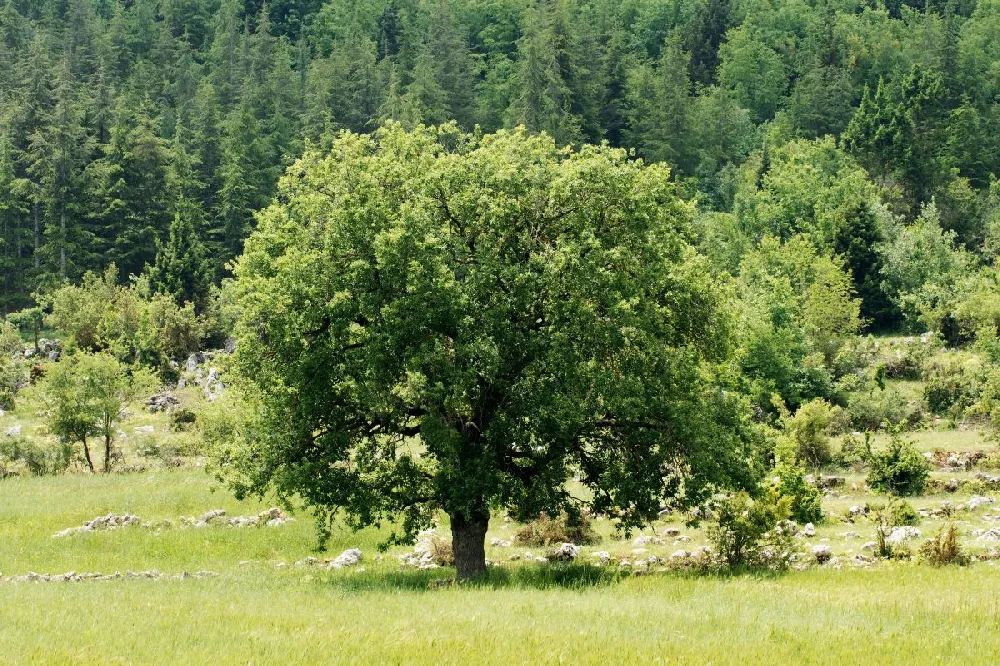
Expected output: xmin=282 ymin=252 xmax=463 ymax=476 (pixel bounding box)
xmin=0 ymin=0 xmax=1000 ymax=340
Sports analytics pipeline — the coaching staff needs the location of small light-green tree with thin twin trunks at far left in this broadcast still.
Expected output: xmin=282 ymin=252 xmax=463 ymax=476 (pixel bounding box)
xmin=43 ymin=353 xmax=152 ymax=473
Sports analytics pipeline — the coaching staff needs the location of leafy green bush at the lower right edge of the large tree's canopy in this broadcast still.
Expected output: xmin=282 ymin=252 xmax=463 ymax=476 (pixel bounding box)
xmin=708 ymin=491 xmax=794 ymax=570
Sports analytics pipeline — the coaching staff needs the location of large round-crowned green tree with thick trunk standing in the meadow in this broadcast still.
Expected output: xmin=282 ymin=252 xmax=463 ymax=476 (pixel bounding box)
xmin=222 ymin=125 xmax=755 ymax=578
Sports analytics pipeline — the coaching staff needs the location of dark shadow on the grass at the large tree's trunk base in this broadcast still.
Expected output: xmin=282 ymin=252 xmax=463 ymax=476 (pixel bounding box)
xmin=329 ymin=564 xmax=787 ymax=592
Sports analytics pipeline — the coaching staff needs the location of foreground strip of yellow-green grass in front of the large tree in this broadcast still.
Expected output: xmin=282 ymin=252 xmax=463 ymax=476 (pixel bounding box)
xmin=0 ymin=565 xmax=1000 ymax=666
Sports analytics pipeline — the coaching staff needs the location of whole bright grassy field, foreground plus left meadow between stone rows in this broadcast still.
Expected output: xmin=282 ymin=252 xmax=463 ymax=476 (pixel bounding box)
xmin=0 ymin=470 xmax=1000 ymax=665
